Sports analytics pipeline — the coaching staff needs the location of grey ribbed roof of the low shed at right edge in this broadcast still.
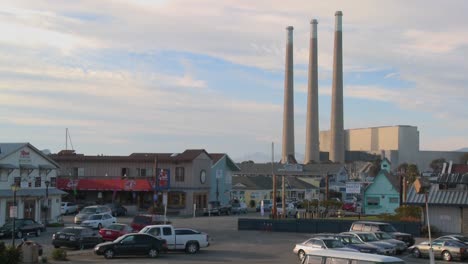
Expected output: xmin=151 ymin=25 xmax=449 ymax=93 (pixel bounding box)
xmin=406 ymin=184 xmax=468 ymax=207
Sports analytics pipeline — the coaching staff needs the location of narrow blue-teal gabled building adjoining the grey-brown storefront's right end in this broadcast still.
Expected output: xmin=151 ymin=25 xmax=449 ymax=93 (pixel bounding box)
xmin=209 ymin=153 xmax=240 ymax=204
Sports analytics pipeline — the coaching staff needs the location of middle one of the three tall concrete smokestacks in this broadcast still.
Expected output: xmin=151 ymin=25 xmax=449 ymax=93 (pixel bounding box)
xmin=304 ymin=19 xmax=320 ymax=164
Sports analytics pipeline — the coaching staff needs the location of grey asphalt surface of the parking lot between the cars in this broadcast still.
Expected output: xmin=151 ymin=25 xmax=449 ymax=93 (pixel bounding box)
xmin=4 ymin=213 xmax=461 ymax=264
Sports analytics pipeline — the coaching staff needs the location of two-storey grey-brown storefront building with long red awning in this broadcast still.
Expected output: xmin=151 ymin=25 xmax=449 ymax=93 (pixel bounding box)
xmin=50 ymin=149 xmax=212 ymax=215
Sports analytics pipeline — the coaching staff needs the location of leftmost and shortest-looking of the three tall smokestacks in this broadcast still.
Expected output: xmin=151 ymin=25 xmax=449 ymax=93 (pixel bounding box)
xmin=281 ymin=26 xmax=296 ymax=164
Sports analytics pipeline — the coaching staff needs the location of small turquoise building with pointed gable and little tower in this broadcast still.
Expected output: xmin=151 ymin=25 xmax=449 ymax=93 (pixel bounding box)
xmin=364 ymin=159 xmax=400 ymax=215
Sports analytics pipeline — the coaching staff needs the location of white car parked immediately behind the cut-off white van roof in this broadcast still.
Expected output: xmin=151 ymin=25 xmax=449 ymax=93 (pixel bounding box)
xmin=293 ymin=237 xmax=358 ymax=260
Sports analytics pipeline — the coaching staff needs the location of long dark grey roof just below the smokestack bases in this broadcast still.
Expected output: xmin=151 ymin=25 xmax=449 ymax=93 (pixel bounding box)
xmin=237 ymin=163 xmax=344 ymax=176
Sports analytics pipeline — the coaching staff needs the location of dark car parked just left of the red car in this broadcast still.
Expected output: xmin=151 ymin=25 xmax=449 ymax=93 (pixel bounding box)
xmin=52 ymin=226 xmax=102 ymax=249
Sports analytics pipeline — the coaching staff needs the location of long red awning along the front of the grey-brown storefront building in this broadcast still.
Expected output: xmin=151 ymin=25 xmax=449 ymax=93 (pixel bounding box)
xmin=57 ymin=178 xmax=153 ymax=191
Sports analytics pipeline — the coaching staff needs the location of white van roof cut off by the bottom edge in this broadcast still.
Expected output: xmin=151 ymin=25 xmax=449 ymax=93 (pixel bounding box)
xmin=301 ymin=249 xmax=405 ymax=264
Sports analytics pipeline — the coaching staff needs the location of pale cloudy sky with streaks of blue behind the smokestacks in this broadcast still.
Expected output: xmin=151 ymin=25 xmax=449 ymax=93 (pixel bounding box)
xmin=0 ymin=0 xmax=468 ymax=161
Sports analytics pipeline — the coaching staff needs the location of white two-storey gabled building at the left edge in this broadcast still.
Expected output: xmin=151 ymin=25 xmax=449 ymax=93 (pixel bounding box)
xmin=0 ymin=143 xmax=66 ymax=225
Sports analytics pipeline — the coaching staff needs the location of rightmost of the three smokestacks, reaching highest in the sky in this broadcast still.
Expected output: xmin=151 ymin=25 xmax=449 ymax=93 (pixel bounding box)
xmin=330 ymin=11 xmax=345 ymax=163
